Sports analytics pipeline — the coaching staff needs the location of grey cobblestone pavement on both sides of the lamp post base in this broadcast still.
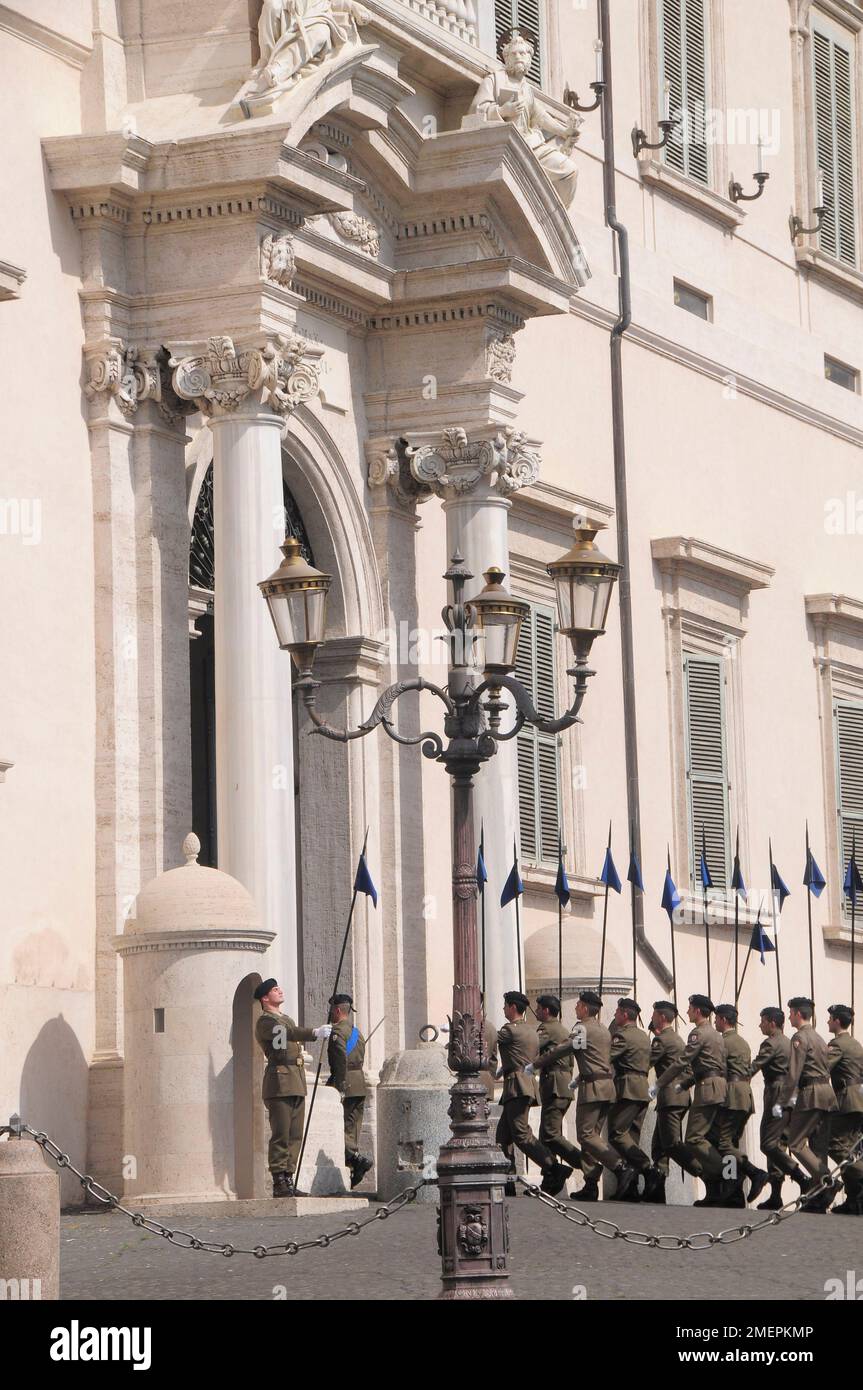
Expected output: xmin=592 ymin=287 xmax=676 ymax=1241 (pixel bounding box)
xmin=60 ymin=1197 xmax=863 ymax=1301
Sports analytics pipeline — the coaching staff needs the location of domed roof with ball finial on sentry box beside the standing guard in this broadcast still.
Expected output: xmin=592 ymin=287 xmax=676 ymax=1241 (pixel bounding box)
xmin=122 ymin=834 xmax=261 ymax=937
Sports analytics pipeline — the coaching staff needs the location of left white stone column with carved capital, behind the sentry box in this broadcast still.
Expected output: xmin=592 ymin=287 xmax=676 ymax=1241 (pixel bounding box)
xmin=171 ymin=334 xmax=320 ymax=1017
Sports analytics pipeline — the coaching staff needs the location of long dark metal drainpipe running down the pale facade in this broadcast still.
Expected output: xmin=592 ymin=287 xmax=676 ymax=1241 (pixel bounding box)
xmin=598 ymin=0 xmax=673 ymax=988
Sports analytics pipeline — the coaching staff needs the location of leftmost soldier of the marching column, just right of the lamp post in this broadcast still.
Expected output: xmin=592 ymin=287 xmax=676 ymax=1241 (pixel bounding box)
xmin=495 ymin=990 xmax=573 ymax=1197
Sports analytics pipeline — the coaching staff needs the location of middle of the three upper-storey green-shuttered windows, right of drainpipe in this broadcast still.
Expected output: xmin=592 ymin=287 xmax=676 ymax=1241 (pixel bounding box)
xmin=657 ymin=0 xmax=710 ymax=183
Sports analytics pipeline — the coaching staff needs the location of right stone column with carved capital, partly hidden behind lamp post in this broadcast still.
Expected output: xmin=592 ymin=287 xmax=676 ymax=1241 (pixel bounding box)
xmin=409 ymin=427 xmax=539 ymax=1017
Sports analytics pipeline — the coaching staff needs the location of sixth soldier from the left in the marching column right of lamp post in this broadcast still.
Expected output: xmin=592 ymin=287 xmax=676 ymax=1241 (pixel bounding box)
xmin=663 ymin=994 xmax=734 ymax=1207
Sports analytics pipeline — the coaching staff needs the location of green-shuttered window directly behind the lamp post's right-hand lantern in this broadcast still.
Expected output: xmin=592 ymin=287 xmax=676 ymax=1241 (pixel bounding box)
xmin=516 ymin=603 xmax=560 ymax=863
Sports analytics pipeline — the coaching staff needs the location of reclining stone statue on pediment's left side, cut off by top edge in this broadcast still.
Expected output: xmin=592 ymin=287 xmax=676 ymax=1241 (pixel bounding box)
xmin=240 ymin=0 xmax=371 ymax=115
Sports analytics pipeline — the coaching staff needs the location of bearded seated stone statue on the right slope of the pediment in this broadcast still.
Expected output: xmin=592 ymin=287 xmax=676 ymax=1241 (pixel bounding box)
xmin=464 ymin=29 xmax=582 ymax=207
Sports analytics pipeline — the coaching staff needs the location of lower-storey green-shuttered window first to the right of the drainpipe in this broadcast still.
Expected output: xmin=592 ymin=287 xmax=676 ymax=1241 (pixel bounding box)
xmin=684 ymin=653 xmax=731 ymax=888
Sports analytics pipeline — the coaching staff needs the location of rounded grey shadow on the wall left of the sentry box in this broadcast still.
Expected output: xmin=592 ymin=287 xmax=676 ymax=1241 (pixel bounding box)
xmin=18 ymin=1015 xmax=89 ymax=1207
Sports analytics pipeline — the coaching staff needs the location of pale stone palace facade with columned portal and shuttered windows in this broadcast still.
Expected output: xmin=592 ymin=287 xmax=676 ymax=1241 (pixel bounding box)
xmin=0 ymin=0 xmax=863 ymax=1197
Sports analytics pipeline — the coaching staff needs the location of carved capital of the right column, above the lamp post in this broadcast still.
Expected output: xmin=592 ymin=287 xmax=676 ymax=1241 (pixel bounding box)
xmin=407 ymin=427 xmax=541 ymax=498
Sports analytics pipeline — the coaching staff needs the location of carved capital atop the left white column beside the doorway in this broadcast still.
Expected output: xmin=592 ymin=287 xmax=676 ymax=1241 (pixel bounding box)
xmin=170 ymin=334 xmax=322 ymax=417
